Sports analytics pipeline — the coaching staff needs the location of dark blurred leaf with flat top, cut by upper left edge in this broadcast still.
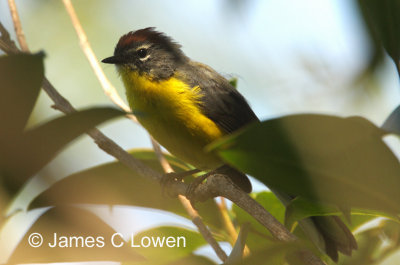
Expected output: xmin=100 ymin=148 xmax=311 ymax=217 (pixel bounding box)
xmin=0 ymin=53 xmax=44 ymax=138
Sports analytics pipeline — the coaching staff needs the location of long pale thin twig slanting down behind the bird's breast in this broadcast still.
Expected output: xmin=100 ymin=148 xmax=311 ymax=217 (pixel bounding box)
xmin=63 ymin=0 xmax=227 ymax=261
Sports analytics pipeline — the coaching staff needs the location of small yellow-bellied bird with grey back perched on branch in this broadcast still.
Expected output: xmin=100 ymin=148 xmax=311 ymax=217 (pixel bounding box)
xmin=102 ymin=28 xmax=357 ymax=261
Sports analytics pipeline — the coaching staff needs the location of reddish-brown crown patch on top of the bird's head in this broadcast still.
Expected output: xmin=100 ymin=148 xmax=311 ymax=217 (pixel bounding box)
xmin=114 ymin=27 xmax=180 ymax=53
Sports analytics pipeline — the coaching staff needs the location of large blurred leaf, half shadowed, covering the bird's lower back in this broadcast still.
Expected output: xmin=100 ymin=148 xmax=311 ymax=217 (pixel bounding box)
xmin=209 ymin=114 xmax=400 ymax=214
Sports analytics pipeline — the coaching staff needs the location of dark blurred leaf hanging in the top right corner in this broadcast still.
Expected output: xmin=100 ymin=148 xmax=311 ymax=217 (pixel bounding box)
xmin=358 ymin=0 xmax=400 ymax=73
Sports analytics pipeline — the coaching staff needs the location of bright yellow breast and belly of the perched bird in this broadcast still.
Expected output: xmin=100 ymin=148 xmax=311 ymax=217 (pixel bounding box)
xmin=120 ymin=69 xmax=224 ymax=170
